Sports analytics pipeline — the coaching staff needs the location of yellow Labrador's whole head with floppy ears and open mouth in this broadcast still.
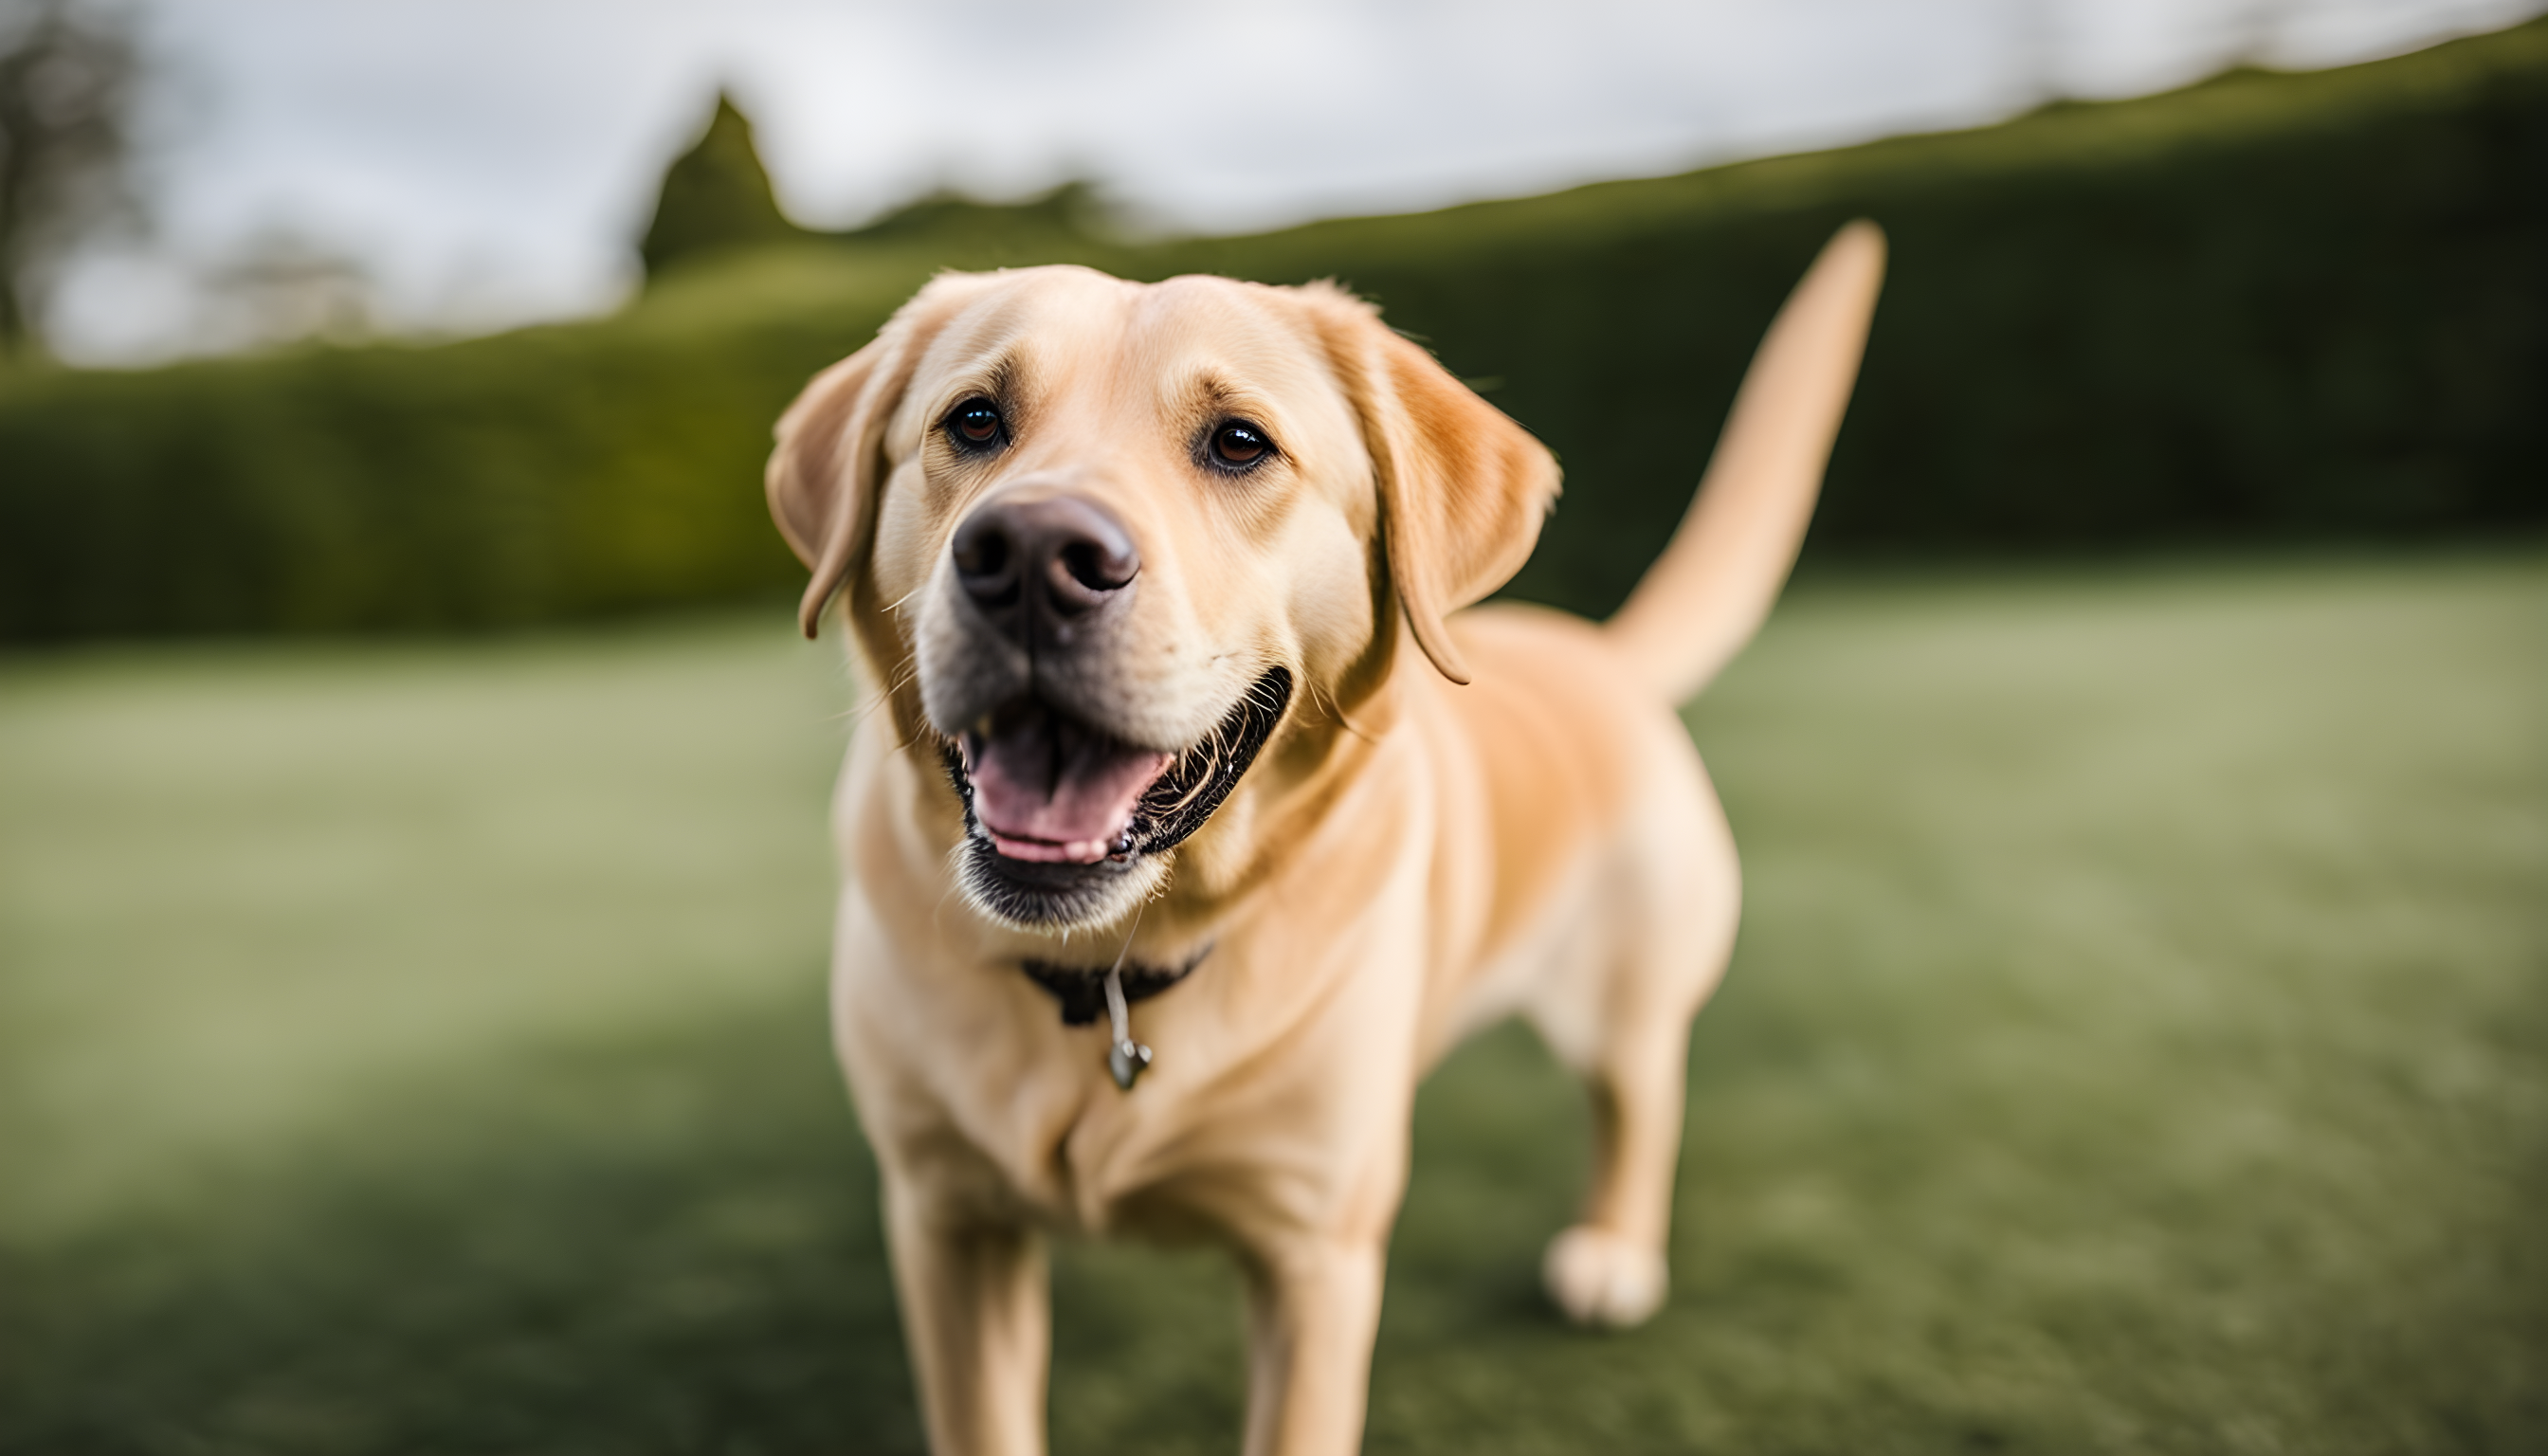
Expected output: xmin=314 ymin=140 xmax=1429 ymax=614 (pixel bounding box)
xmin=770 ymin=267 xmax=1556 ymax=931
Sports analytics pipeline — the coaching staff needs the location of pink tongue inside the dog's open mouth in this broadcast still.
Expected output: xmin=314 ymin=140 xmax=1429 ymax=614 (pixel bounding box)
xmin=963 ymin=714 xmax=1167 ymax=864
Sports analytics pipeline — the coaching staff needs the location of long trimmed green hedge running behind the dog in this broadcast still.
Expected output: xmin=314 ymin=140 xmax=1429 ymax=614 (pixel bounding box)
xmin=0 ymin=23 xmax=2548 ymax=640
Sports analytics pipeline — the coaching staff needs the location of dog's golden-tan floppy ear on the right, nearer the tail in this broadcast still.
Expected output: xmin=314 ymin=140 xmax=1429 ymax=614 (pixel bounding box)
xmin=1300 ymin=283 xmax=1556 ymax=683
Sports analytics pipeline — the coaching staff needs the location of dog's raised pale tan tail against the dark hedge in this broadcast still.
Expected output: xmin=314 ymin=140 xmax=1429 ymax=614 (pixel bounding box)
xmin=1603 ymin=219 xmax=1885 ymax=703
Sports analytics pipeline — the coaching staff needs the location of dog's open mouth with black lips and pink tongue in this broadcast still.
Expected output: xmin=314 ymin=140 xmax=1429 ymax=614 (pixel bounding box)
xmin=940 ymin=668 xmax=1292 ymax=920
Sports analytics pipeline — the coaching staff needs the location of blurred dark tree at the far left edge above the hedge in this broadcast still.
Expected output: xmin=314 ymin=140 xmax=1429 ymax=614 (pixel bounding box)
xmin=0 ymin=0 xmax=135 ymax=355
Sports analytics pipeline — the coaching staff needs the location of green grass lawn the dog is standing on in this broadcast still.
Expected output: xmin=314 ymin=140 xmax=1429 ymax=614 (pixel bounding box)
xmin=0 ymin=554 xmax=2548 ymax=1456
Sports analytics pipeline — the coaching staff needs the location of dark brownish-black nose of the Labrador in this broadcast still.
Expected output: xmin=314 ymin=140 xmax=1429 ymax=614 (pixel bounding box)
xmin=953 ymin=495 xmax=1141 ymax=646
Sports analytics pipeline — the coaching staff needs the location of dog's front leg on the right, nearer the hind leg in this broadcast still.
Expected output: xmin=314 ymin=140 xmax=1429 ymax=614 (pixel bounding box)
xmin=1246 ymin=1237 xmax=1386 ymax=1456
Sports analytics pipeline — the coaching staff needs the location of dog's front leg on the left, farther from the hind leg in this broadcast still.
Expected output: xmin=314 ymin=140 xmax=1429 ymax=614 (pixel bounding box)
xmin=886 ymin=1189 xmax=1052 ymax=1456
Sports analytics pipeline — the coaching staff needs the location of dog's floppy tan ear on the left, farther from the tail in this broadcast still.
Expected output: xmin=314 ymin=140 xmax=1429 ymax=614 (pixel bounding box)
xmin=764 ymin=273 xmax=989 ymax=638
